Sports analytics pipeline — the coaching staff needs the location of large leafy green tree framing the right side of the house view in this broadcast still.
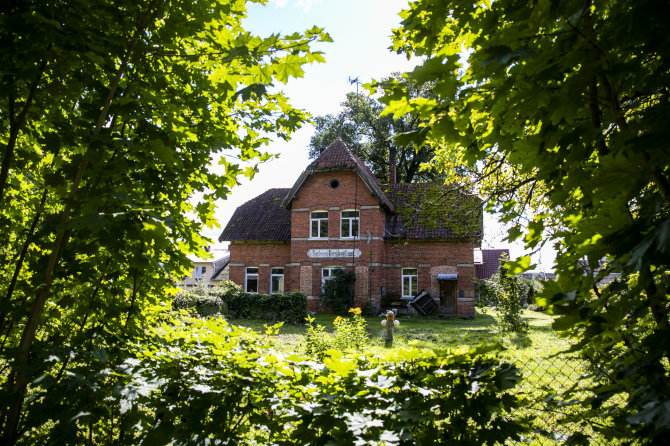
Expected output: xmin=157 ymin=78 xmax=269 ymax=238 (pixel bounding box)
xmin=373 ymin=0 xmax=670 ymax=442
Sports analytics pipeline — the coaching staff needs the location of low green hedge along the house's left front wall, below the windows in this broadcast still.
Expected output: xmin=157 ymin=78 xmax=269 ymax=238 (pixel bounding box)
xmin=172 ymin=281 xmax=307 ymax=325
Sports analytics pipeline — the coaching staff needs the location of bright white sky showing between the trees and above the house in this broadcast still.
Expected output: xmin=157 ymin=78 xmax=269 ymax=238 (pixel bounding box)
xmin=203 ymin=0 xmax=554 ymax=271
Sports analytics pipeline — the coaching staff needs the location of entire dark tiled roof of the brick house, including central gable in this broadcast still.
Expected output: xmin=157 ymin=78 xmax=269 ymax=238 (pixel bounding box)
xmin=219 ymin=139 xmax=483 ymax=242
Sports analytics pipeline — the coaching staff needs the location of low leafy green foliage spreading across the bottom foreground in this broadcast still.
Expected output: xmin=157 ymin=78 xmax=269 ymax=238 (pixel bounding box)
xmin=9 ymin=314 xmax=526 ymax=445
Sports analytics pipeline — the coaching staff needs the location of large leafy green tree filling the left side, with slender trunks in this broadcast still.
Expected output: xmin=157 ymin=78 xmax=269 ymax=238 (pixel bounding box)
xmin=0 ymin=0 xmax=329 ymax=444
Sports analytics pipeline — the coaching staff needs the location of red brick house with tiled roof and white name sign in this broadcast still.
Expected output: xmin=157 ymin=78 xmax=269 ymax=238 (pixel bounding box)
xmin=219 ymin=139 xmax=482 ymax=317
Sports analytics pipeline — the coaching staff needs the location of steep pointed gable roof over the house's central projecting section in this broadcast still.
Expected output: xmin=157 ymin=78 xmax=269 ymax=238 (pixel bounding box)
xmin=282 ymin=138 xmax=394 ymax=212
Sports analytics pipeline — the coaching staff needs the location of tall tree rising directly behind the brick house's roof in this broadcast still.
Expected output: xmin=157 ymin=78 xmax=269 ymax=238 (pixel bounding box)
xmin=309 ymin=74 xmax=444 ymax=183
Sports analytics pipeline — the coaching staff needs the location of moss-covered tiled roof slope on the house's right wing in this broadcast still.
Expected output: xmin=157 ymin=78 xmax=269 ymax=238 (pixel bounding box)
xmin=384 ymin=183 xmax=483 ymax=239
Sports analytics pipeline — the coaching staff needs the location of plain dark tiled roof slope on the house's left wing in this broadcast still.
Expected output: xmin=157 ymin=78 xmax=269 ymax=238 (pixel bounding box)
xmin=219 ymin=189 xmax=291 ymax=242
